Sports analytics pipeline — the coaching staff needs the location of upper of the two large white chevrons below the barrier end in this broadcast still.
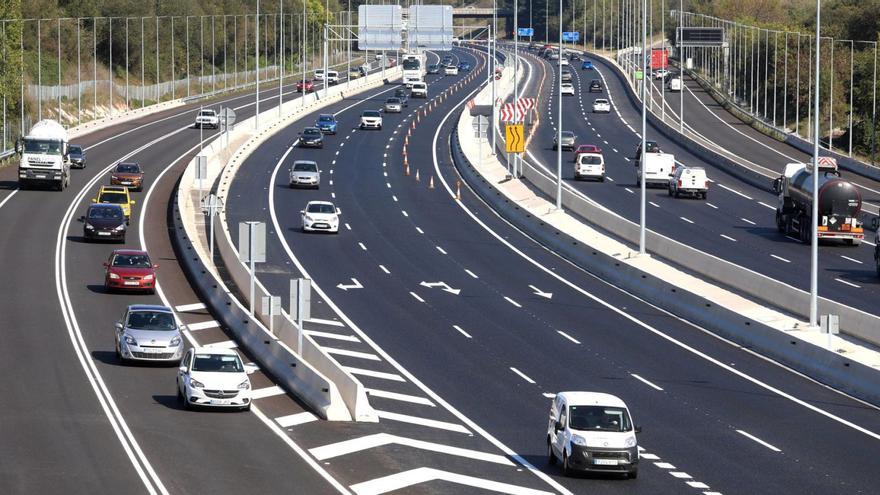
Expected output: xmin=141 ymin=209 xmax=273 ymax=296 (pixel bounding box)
xmin=309 ymin=433 xmax=513 ymax=464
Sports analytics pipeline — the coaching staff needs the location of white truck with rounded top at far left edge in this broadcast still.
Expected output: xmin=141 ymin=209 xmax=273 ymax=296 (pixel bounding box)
xmin=15 ymin=120 xmax=70 ymax=191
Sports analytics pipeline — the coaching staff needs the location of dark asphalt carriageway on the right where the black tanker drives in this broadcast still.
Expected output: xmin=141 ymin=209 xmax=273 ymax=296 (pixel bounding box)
xmin=524 ymin=48 xmax=880 ymax=320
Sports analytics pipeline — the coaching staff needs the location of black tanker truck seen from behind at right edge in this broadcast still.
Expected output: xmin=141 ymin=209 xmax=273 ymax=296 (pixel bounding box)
xmin=773 ymin=158 xmax=865 ymax=246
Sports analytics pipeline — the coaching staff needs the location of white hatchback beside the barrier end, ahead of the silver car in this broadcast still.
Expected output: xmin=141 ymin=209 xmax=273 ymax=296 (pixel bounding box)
xmin=177 ymin=347 xmax=251 ymax=411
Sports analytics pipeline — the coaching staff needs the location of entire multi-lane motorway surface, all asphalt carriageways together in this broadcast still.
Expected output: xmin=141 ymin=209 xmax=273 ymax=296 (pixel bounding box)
xmin=0 ymin=36 xmax=880 ymax=494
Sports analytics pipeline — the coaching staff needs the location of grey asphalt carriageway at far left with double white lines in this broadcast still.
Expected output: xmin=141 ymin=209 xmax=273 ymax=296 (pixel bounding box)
xmin=0 ymin=74 xmax=368 ymax=493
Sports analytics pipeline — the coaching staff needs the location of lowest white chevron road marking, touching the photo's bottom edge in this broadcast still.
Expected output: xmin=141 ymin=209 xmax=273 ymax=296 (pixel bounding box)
xmin=351 ymin=467 xmax=551 ymax=495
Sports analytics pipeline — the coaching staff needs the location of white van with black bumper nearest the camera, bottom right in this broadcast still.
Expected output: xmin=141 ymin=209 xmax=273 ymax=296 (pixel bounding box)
xmin=547 ymin=392 xmax=642 ymax=479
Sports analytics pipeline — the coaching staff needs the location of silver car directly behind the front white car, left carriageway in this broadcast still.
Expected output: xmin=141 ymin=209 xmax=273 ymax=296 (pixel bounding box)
xmin=115 ymin=304 xmax=183 ymax=363
